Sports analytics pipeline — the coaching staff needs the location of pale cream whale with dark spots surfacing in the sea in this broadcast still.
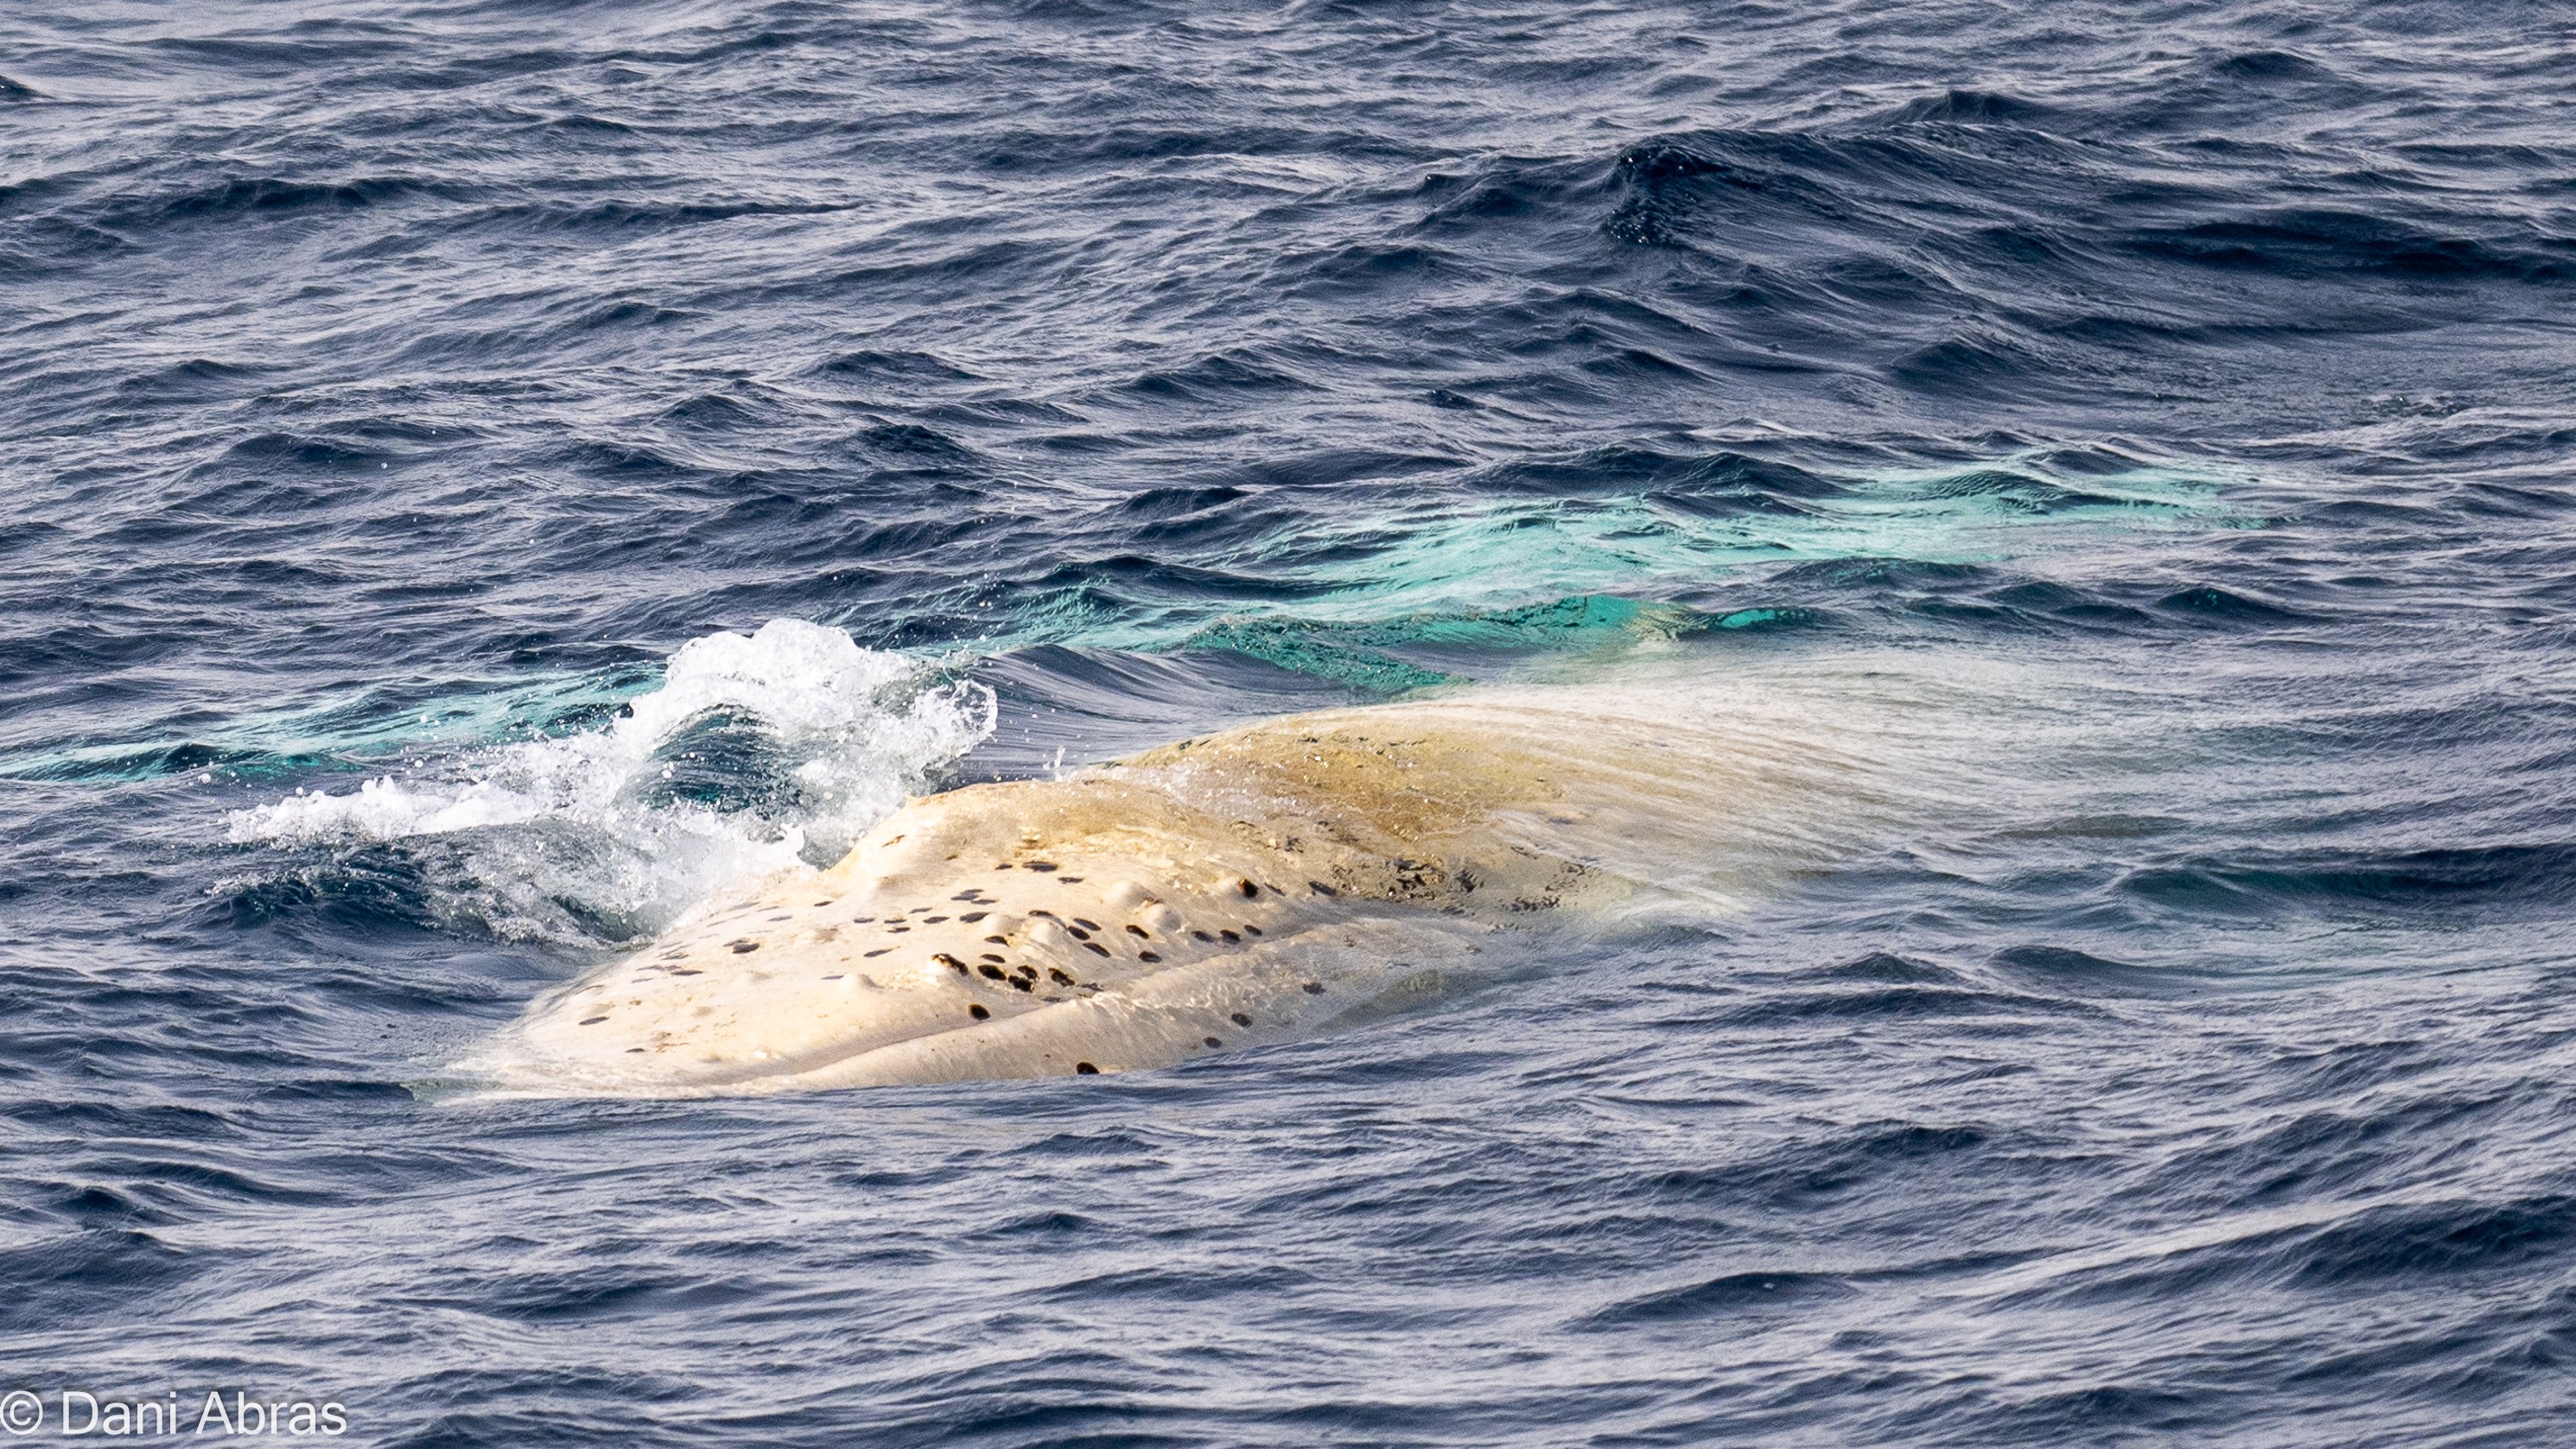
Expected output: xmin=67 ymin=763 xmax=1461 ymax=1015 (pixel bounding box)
xmin=443 ymin=669 xmax=1988 ymax=1096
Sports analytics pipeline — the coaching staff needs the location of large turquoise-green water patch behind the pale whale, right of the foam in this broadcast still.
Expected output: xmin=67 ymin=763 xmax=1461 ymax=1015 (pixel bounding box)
xmin=1097 ymin=455 xmax=2248 ymax=692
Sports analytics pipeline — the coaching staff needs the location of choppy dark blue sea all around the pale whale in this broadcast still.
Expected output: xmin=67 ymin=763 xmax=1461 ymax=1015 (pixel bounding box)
xmin=0 ymin=0 xmax=2576 ymax=1449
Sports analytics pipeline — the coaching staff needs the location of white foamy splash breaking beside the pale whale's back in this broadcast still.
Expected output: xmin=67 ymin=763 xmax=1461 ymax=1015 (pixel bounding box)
xmin=229 ymin=618 xmax=995 ymax=937
